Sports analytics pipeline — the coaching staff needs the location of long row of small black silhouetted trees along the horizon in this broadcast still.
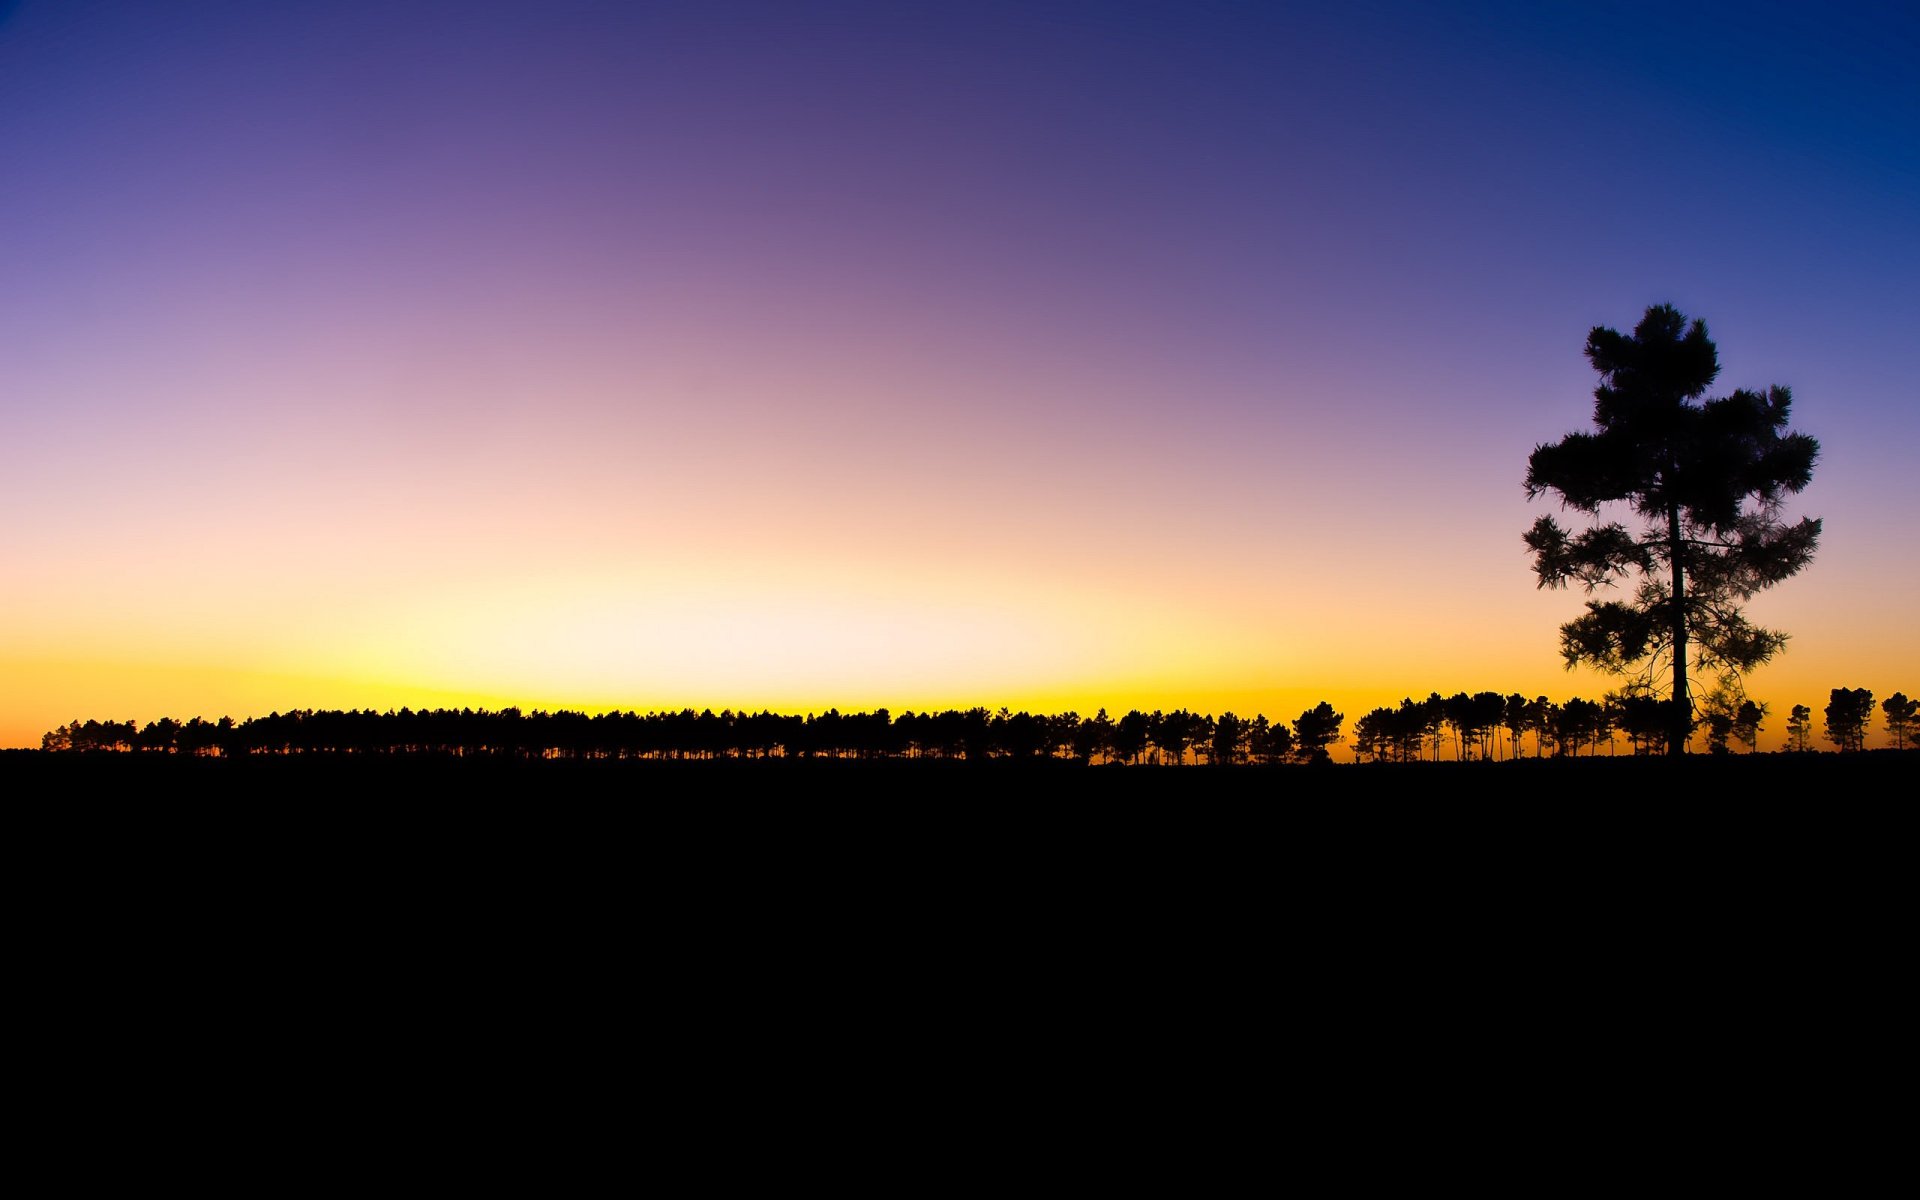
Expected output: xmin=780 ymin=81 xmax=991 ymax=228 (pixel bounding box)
xmin=40 ymin=687 xmax=1920 ymax=766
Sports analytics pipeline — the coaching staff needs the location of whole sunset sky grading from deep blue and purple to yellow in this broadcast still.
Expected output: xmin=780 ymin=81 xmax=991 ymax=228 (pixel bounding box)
xmin=0 ymin=0 xmax=1920 ymax=749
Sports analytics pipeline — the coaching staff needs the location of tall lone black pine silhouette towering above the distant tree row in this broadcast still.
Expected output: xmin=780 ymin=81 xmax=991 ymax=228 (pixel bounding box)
xmin=1526 ymin=305 xmax=1820 ymax=755
